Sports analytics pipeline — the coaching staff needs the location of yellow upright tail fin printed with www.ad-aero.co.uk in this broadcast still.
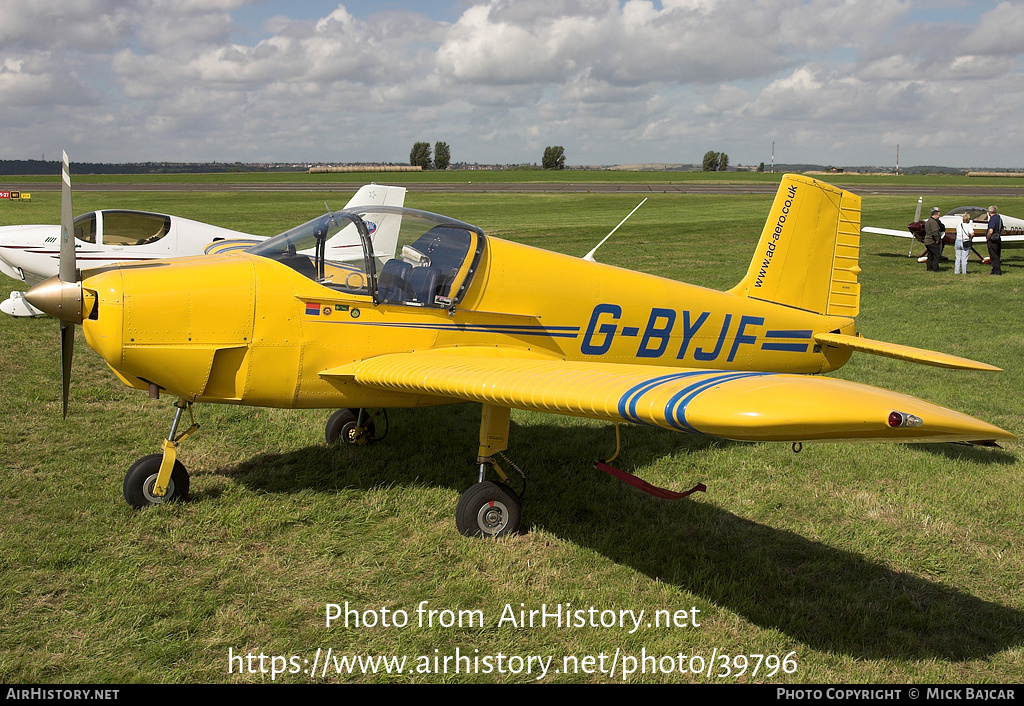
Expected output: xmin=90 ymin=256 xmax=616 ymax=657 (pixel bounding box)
xmin=731 ymin=174 xmax=860 ymax=317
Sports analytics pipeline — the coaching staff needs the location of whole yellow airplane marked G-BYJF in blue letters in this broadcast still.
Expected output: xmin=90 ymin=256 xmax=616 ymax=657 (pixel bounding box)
xmin=28 ymin=153 xmax=1015 ymax=535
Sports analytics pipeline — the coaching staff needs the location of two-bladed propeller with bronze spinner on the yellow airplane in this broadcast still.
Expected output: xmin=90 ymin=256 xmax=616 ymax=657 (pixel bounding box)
xmin=25 ymin=153 xmax=83 ymax=418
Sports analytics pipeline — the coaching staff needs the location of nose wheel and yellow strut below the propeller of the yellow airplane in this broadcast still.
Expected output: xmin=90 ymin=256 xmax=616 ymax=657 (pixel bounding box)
xmin=124 ymin=400 xmax=199 ymax=509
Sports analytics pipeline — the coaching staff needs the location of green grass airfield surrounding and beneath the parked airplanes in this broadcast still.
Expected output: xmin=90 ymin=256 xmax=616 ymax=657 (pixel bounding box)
xmin=0 ymin=177 xmax=1024 ymax=683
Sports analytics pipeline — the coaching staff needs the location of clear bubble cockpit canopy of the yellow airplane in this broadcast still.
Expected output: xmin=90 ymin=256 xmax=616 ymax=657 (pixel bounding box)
xmin=249 ymin=206 xmax=484 ymax=307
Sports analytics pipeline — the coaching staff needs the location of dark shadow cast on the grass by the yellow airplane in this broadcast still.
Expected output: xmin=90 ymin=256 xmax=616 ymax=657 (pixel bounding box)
xmin=211 ymin=406 xmax=1024 ymax=662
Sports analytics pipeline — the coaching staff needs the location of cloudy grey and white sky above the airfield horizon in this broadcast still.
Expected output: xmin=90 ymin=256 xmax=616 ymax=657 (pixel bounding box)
xmin=0 ymin=0 xmax=1024 ymax=167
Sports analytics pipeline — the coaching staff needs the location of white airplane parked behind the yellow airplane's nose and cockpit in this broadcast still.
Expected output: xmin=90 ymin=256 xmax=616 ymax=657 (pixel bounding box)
xmin=0 ymin=183 xmax=406 ymax=317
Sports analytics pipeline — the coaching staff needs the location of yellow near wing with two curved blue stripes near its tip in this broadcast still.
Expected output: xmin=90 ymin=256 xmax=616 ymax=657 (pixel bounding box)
xmin=321 ymin=348 xmax=1015 ymax=442
